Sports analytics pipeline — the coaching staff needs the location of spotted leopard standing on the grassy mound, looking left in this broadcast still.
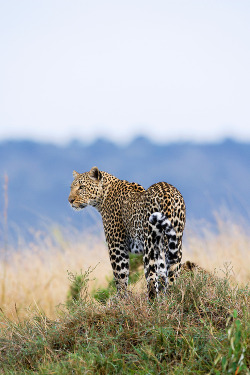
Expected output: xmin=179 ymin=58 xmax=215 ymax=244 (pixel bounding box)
xmin=68 ymin=167 xmax=186 ymax=300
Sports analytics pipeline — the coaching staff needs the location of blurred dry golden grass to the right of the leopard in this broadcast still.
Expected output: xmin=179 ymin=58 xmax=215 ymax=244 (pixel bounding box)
xmin=183 ymin=217 xmax=250 ymax=284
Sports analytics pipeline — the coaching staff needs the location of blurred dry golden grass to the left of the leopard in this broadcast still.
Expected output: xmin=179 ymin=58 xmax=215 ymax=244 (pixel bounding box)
xmin=0 ymin=229 xmax=112 ymax=319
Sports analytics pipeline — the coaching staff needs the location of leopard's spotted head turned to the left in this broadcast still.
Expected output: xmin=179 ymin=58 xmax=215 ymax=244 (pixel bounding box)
xmin=68 ymin=167 xmax=103 ymax=210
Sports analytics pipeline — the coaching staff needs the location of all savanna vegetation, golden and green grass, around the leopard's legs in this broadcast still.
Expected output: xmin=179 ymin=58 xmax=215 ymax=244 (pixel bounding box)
xmin=0 ymin=219 xmax=250 ymax=374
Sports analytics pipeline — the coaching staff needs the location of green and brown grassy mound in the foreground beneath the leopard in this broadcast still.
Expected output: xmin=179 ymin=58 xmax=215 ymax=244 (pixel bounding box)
xmin=0 ymin=270 xmax=250 ymax=375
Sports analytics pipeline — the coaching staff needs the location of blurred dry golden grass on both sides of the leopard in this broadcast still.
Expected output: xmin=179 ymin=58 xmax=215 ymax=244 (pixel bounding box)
xmin=0 ymin=220 xmax=250 ymax=320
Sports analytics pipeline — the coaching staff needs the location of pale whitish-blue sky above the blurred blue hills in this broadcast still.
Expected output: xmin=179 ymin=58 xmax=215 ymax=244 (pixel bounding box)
xmin=0 ymin=0 xmax=250 ymax=142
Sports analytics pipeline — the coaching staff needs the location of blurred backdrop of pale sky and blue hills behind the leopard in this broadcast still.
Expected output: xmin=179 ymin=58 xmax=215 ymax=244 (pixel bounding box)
xmin=0 ymin=0 xmax=250 ymax=242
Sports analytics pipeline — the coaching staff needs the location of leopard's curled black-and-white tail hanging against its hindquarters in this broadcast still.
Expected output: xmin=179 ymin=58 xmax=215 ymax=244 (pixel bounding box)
xmin=149 ymin=212 xmax=178 ymax=254
